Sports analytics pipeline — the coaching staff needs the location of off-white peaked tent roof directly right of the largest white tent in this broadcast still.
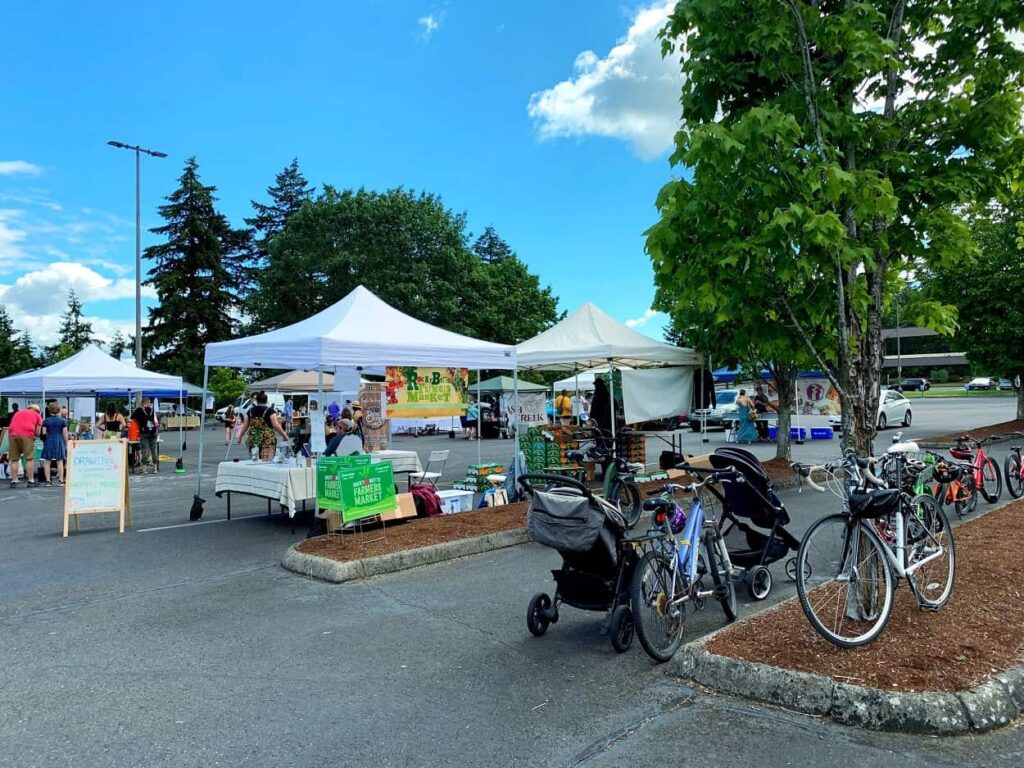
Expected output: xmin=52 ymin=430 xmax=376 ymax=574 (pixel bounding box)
xmin=516 ymin=302 xmax=700 ymax=371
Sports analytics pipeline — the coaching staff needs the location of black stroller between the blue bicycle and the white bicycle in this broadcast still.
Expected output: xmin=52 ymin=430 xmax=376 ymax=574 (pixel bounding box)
xmin=709 ymin=445 xmax=800 ymax=600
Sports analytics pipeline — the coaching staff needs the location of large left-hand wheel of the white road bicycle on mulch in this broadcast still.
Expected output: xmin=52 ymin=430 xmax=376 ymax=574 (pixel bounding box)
xmin=797 ymin=514 xmax=894 ymax=648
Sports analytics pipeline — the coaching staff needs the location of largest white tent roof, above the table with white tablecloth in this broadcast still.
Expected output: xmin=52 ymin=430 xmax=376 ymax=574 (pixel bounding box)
xmin=206 ymin=286 xmax=515 ymax=370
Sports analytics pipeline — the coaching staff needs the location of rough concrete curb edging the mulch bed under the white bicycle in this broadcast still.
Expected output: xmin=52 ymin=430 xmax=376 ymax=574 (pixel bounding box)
xmin=669 ymin=598 xmax=1024 ymax=735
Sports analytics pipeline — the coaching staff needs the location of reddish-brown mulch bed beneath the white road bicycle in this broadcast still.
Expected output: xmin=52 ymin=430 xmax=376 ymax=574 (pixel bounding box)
xmin=707 ymin=501 xmax=1024 ymax=692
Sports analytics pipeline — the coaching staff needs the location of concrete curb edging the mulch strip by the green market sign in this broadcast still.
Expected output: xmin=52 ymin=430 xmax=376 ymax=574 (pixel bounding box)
xmin=281 ymin=528 xmax=529 ymax=584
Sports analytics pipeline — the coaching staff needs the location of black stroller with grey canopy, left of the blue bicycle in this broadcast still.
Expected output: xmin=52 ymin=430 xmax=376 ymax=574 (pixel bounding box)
xmin=519 ymin=474 xmax=637 ymax=652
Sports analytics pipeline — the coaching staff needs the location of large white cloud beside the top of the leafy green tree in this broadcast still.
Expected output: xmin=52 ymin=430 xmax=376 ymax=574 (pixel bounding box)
xmin=527 ymin=0 xmax=683 ymax=159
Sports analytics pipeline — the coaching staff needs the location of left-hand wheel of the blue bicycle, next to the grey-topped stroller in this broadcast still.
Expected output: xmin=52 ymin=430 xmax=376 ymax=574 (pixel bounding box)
xmin=630 ymin=552 xmax=686 ymax=663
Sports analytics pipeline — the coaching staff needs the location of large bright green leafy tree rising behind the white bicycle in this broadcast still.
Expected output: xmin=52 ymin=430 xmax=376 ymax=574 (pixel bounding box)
xmin=648 ymin=0 xmax=1024 ymax=453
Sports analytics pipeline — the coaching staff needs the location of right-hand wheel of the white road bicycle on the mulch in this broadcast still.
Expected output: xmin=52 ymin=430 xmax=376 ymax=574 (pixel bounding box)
xmin=905 ymin=496 xmax=956 ymax=609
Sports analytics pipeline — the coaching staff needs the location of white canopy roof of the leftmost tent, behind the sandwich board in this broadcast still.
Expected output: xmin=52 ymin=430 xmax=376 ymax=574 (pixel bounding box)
xmin=0 ymin=346 xmax=182 ymax=394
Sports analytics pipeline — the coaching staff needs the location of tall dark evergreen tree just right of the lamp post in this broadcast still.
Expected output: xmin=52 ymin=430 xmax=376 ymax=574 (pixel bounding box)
xmin=143 ymin=158 xmax=249 ymax=381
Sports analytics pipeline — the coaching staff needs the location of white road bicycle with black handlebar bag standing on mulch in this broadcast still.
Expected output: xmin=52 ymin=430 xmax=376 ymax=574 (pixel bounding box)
xmin=794 ymin=457 xmax=956 ymax=648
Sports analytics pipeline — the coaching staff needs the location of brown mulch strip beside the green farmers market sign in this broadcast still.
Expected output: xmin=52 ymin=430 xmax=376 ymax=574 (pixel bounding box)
xmin=295 ymin=502 xmax=528 ymax=562
